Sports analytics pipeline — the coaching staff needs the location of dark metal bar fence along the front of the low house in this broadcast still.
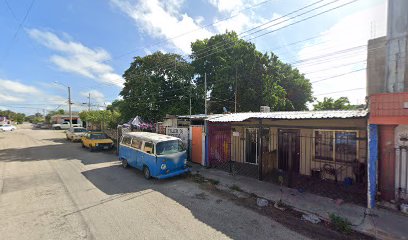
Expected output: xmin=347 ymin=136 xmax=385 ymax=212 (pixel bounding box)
xmin=208 ymin=124 xmax=367 ymax=204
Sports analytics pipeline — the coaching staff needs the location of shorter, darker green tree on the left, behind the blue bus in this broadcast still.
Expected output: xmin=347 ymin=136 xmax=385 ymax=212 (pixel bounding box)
xmin=120 ymin=52 xmax=197 ymax=121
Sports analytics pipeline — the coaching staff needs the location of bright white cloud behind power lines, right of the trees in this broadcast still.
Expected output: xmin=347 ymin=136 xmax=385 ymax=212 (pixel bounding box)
xmin=295 ymin=1 xmax=386 ymax=106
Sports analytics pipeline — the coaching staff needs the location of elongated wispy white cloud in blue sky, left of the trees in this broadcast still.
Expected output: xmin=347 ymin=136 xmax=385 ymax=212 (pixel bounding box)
xmin=27 ymin=29 xmax=124 ymax=87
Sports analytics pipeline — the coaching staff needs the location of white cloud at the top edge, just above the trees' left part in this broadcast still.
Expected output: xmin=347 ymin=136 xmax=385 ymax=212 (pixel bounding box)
xmin=111 ymin=0 xmax=212 ymax=53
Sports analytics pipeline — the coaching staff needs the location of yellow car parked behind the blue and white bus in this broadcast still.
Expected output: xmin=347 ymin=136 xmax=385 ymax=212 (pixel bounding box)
xmin=81 ymin=132 xmax=113 ymax=152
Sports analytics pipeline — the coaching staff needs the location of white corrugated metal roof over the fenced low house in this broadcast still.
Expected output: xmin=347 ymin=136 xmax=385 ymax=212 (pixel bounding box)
xmin=208 ymin=110 xmax=368 ymax=122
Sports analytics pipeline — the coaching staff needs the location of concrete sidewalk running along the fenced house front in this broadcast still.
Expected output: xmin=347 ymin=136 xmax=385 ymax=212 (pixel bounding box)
xmin=192 ymin=164 xmax=408 ymax=239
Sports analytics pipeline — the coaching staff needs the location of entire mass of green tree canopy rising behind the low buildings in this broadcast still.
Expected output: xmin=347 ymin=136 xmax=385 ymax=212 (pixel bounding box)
xmin=119 ymin=32 xmax=313 ymax=121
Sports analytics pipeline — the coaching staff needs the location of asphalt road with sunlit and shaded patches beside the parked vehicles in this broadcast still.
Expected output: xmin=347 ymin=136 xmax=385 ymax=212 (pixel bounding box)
xmin=0 ymin=125 xmax=304 ymax=239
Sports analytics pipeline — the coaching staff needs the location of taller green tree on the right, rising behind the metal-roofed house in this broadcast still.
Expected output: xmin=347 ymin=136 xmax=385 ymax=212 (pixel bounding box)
xmin=191 ymin=32 xmax=313 ymax=112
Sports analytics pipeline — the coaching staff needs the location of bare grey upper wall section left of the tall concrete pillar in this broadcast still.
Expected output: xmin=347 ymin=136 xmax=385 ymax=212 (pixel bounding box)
xmin=367 ymin=37 xmax=387 ymax=96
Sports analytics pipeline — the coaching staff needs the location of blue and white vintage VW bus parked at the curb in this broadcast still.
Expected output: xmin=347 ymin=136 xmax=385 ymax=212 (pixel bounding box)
xmin=119 ymin=132 xmax=190 ymax=179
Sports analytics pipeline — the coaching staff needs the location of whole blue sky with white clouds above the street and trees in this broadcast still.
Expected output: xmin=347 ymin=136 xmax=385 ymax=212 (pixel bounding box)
xmin=0 ymin=0 xmax=386 ymax=114
